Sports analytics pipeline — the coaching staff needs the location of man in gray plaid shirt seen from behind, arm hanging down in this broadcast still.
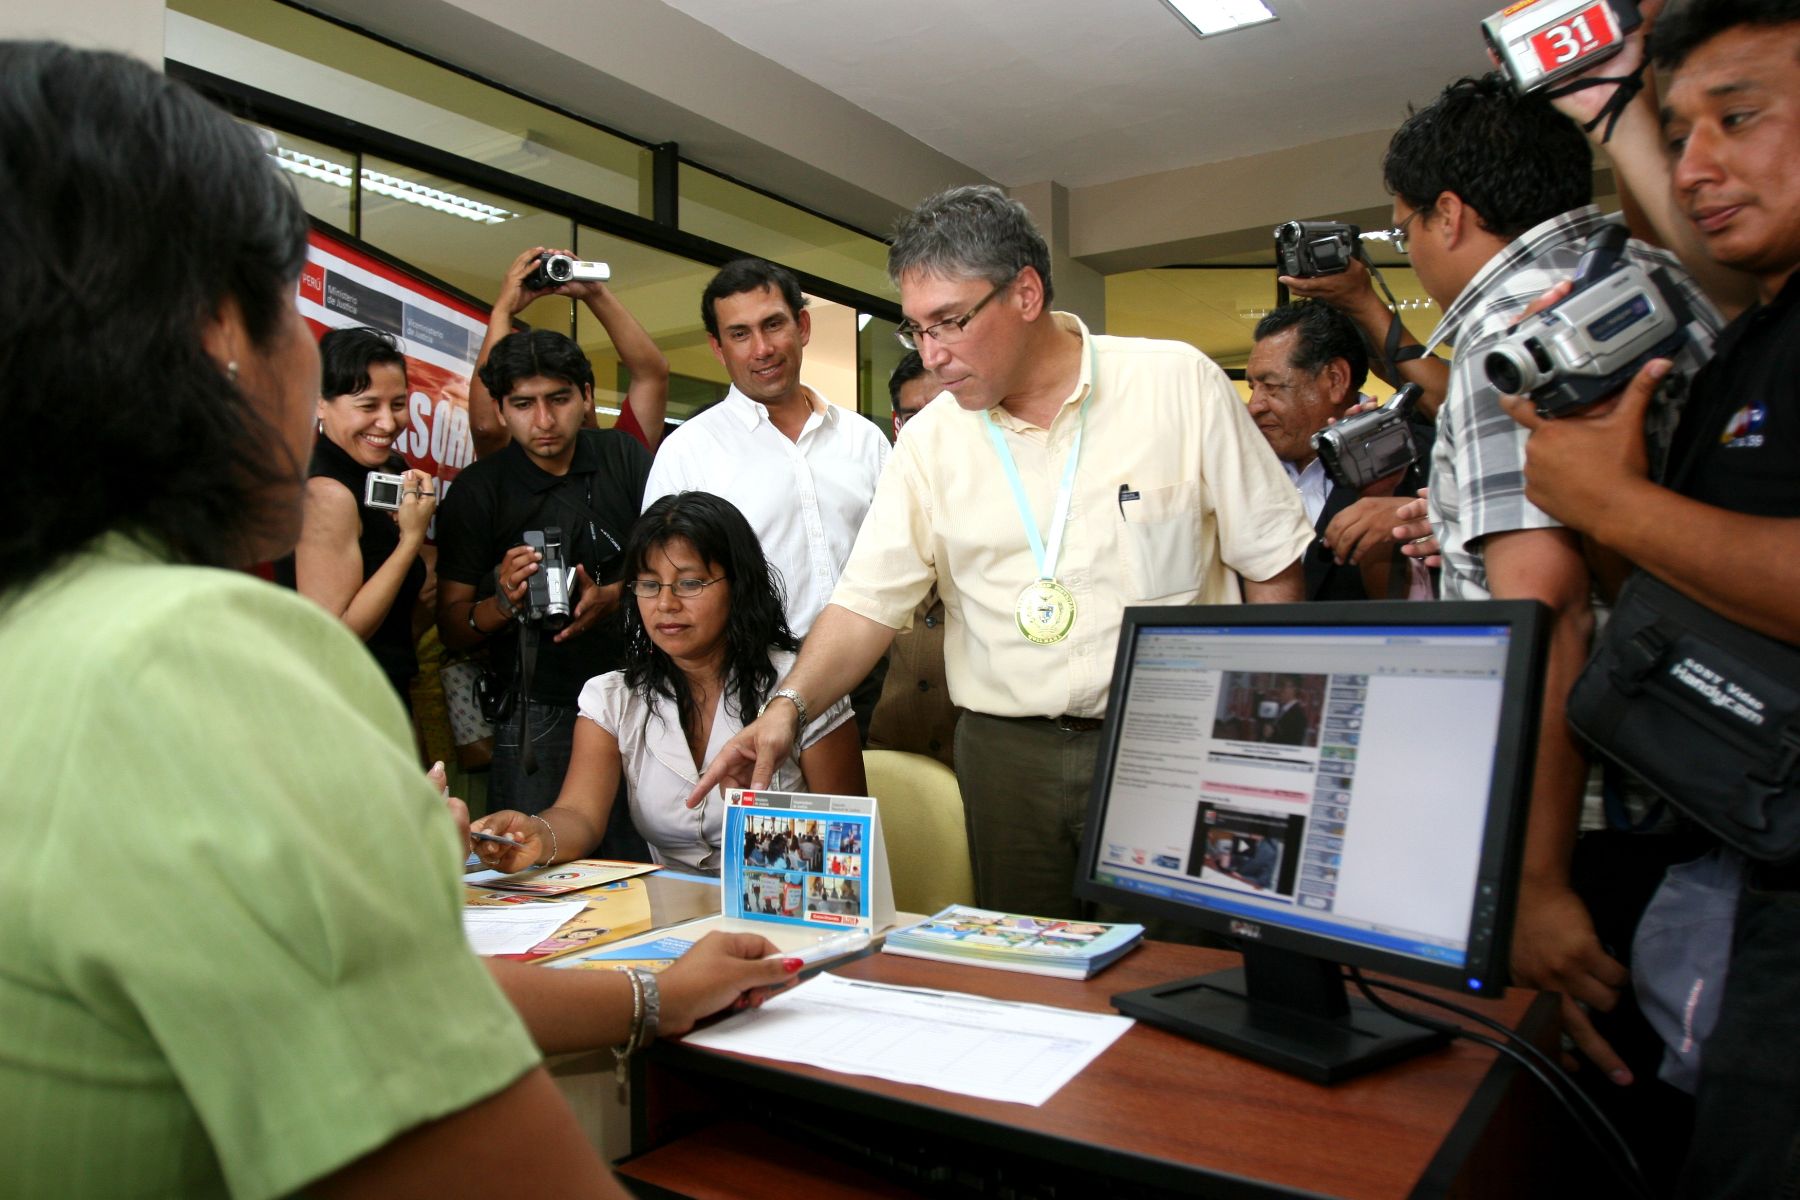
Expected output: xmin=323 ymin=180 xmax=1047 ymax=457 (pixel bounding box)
xmin=1382 ymin=76 xmax=1717 ymax=1083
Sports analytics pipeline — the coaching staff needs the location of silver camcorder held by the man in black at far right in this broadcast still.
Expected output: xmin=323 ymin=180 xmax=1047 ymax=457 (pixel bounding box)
xmin=1481 ymin=225 xmax=1692 ymax=417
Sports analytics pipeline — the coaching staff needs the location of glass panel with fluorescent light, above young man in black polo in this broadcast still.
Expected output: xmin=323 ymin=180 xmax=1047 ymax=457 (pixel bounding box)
xmin=362 ymin=158 xmax=574 ymax=333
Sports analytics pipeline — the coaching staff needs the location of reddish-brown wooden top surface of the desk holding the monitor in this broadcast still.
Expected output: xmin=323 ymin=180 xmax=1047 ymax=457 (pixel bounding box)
xmin=628 ymin=943 xmax=1555 ymax=1196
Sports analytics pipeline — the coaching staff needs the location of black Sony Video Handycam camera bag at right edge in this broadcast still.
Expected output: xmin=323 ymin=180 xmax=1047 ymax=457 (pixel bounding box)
xmin=1568 ymin=570 xmax=1800 ymax=864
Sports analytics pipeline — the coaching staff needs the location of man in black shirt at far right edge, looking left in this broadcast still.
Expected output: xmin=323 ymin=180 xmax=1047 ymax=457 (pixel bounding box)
xmin=1508 ymin=0 xmax=1800 ymax=1196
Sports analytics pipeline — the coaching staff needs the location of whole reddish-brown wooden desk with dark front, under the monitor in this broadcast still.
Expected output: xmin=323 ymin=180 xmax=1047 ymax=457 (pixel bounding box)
xmin=621 ymin=945 xmax=1562 ymax=1200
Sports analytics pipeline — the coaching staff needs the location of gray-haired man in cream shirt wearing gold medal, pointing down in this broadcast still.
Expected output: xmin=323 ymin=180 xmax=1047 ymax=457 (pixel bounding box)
xmin=697 ymin=187 xmax=1312 ymax=916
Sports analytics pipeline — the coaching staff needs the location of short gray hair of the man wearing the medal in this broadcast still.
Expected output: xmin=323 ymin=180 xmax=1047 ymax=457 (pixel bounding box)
xmin=887 ymin=184 xmax=1055 ymax=306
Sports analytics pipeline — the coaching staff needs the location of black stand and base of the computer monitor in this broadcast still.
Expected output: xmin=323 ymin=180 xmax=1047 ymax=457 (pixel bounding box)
xmin=1112 ymin=945 xmax=1445 ymax=1083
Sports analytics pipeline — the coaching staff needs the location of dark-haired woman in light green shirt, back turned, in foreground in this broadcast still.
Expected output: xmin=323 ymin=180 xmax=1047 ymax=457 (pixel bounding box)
xmin=0 ymin=41 xmax=797 ymax=1196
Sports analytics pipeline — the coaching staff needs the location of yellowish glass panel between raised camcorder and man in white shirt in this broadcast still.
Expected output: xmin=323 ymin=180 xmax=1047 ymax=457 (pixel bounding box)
xmin=576 ymin=225 xmax=731 ymax=425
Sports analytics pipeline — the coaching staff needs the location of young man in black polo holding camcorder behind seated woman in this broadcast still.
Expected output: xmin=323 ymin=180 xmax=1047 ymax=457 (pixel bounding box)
xmin=437 ymin=329 xmax=650 ymax=834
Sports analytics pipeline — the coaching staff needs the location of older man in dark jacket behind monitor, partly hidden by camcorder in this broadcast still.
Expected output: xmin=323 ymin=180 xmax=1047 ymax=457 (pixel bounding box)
xmin=1244 ymin=300 xmax=1422 ymax=599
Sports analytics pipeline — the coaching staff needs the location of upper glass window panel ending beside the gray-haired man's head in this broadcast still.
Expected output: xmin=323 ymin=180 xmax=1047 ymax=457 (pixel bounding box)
xmin=679 ymin=162 xmax=893 ymax=295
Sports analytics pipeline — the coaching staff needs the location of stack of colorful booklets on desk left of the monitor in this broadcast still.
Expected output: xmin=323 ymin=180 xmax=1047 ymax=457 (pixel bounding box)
xmin=882 ymin=905 xmax=1143 ymax=979
